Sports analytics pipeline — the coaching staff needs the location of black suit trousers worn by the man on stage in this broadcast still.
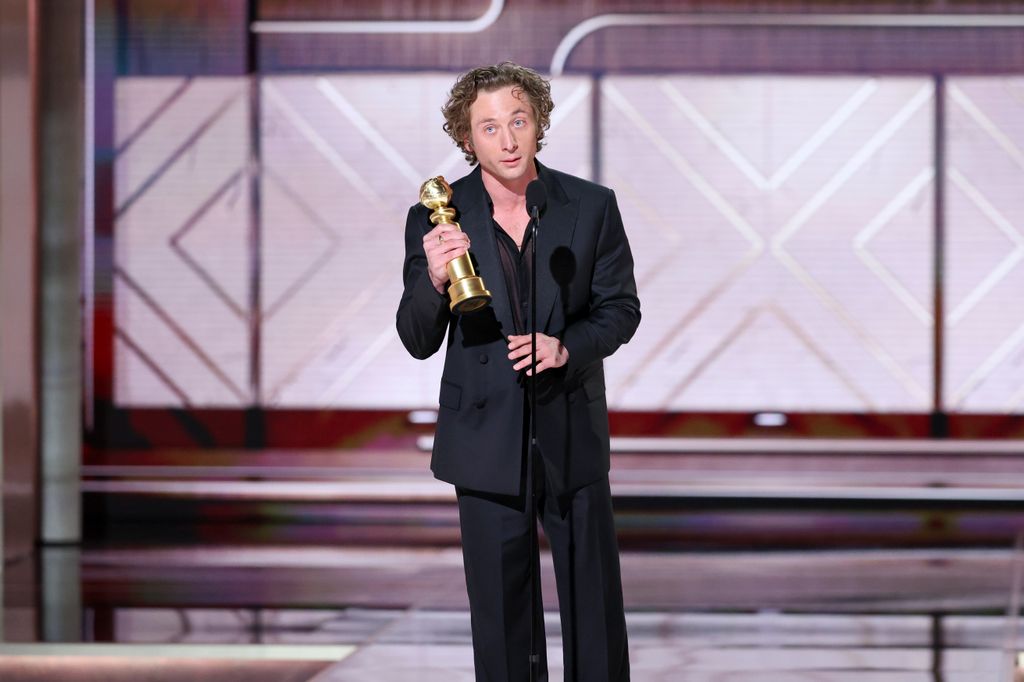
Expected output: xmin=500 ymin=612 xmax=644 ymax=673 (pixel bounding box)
xmin=458 ymin=450 xmax=630 ymax=682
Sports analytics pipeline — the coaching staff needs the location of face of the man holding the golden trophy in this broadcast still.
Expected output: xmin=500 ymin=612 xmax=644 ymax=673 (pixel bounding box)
xmin=466 ymin=85 xmax=537 ymax=183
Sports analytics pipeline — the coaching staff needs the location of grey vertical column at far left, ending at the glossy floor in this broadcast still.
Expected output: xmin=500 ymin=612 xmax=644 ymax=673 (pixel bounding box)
xmin=38 ymin=3 xmax=84 ymax=543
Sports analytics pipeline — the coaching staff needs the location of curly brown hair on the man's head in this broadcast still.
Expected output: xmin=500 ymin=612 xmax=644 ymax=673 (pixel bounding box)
xmin=441 ymin=61 xmax=555 ymax=166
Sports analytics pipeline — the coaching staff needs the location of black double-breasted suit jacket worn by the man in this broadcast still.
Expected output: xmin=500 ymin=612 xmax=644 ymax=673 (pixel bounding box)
xmin=397 ymin=163 xmax=640 ymax=495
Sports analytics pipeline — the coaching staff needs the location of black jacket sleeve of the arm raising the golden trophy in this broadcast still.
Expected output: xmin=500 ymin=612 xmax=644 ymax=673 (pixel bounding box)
xmin=395 ymin=206 xmax=452 ymax=359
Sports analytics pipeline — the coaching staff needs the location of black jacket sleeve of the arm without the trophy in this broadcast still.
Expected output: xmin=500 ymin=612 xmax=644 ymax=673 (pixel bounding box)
xmin=562 ymin=190 xmax=640 ymax=374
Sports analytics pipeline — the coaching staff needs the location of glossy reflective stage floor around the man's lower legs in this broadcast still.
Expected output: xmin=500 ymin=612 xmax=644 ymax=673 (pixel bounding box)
xmin=0 ymin=546 xmax=1024 ymax=682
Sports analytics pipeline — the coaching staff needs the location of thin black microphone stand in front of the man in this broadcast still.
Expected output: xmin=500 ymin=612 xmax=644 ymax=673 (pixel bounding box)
xmin=526 ymin=197 xmax=544 ymax=682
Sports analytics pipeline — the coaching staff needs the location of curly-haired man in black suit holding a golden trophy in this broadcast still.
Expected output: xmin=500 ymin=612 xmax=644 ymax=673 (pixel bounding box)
xmin=397 ymin=62 xmax=640 ymax=682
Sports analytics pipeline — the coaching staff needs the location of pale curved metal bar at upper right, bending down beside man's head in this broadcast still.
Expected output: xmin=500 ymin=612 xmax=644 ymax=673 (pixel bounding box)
xmin=551 ymin=13 xmax=1024 ymax=76
